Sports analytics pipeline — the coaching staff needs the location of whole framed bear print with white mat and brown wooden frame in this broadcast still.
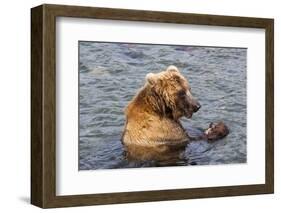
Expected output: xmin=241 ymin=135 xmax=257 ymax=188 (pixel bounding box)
xmin=31 ymin=5 xmax=274 ymax=208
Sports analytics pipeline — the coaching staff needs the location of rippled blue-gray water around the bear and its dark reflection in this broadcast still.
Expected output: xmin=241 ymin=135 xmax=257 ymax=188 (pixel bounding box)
xmin=79 ymin=42 xmax=247 ymax=170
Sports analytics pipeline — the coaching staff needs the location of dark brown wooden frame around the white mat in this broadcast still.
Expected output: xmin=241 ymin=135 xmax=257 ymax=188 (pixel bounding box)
xmin=31 ymin=5 xmax=274 ymax=208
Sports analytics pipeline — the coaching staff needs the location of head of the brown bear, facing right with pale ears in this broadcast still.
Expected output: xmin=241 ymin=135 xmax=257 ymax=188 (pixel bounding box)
xmin=146 ymin=65 xmax=201 ymax=120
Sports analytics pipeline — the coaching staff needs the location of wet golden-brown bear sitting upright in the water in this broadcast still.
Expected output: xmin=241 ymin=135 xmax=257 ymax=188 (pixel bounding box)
xmin=122 ymin=65 xmax=201 ymax=150
